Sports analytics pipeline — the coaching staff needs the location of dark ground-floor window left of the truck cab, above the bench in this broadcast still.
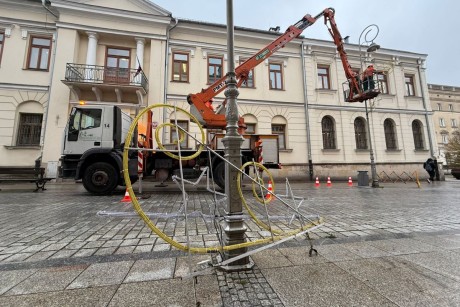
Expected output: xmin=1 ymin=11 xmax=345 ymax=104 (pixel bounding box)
xmin=16 ymin=113 xmax=43 ymax=146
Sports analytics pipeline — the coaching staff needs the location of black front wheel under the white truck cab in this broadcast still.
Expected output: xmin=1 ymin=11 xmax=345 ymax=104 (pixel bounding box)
xmin=83 ymin=162 xmax=118 ymax=195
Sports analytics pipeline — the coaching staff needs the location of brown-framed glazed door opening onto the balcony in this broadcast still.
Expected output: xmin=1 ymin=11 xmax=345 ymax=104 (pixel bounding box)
xmin=104 ymin=47 xmax=131 ymax=83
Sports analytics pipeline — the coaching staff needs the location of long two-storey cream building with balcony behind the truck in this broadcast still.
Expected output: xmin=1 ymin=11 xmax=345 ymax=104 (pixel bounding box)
xmin=0 ymin=0 xmax=438 ymax=182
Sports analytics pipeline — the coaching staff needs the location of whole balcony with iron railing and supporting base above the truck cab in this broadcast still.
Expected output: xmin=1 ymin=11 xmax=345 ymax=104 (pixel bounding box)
xmin=62 ymin=63 xmax=148 ymax=105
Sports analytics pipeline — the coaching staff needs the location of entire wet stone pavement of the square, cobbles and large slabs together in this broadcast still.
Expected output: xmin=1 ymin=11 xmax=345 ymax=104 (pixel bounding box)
xmin=0 ymin=180 xmax=460 ymax=306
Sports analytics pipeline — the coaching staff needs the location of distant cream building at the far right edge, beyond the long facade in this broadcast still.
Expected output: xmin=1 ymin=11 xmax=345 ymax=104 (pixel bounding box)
xmin=428 ymin=84 xmax=460 ymax=165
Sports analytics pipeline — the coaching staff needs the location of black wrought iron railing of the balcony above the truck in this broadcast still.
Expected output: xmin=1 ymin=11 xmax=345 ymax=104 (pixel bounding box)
xmin=65 ymin=63 xmax=148 ymax=93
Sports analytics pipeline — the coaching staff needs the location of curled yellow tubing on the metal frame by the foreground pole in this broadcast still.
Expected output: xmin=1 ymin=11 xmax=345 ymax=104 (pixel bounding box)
xmin=123 ymin=104 xmax=323 ymax=254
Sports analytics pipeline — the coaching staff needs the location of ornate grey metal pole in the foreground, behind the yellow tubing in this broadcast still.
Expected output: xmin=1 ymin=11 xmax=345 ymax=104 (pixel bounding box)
xmin=220 ymin=0 xmax=254 ymax=271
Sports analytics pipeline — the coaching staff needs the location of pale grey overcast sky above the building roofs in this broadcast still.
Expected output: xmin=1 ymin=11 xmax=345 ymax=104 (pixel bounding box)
xmin=152 ymin=0 xmax=460 ymax=86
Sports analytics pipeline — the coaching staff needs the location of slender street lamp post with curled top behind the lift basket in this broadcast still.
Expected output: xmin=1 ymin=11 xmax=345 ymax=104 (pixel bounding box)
xmin=359 ymin=24 xmax=380 ymax=188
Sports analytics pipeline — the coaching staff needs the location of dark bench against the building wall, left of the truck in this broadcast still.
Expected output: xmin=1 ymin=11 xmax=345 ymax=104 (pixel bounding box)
xmin=0 ymin=166 xmax=54 ymax=192
